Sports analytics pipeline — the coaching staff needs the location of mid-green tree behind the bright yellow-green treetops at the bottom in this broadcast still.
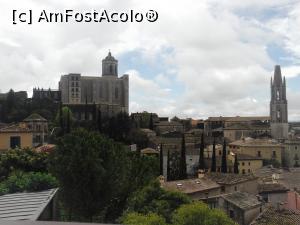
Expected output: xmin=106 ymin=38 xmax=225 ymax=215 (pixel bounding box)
xmin=127 ymin=180 xmax=191 ymax=222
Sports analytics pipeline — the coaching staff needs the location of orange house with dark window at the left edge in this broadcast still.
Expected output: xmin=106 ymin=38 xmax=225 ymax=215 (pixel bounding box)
xmin=0 ymin=123 xmax=33 ymax=151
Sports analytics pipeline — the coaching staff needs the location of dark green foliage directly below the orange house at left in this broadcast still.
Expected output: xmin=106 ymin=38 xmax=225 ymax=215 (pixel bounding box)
xmin=0 ymin=149 xmax=48 ymax=181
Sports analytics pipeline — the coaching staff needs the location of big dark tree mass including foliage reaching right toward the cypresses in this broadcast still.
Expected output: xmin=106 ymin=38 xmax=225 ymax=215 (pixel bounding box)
xmin=50 ymin=129 xmax=159 ymax=221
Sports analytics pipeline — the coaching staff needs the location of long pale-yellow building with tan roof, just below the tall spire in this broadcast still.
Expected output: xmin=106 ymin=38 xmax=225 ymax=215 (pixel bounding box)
xmin=228 ymin=138 xmax=283 ymax=163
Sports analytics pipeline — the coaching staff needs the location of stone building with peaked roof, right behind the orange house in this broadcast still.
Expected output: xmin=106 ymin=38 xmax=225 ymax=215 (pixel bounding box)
xmin=23 ymin=113 xmax=48 ymax=147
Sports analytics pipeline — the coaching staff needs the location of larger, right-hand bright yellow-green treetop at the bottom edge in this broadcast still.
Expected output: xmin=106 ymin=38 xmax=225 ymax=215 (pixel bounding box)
xmin=172 ymin=201 xmax=235 ymax=225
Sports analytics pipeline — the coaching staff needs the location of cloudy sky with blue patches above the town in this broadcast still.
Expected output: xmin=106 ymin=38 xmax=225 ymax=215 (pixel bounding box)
xmin=0 ymin=0 xmax=300 ymax=120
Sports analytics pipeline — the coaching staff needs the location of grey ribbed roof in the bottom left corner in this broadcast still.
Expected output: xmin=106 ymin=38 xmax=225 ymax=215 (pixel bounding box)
xmin=0 ymin=189 xmax=58 ymax=221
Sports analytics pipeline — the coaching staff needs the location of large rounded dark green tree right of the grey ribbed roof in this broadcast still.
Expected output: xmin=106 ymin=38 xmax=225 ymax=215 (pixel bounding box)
xmin=50 ymin=129 xmax=129 ymax=221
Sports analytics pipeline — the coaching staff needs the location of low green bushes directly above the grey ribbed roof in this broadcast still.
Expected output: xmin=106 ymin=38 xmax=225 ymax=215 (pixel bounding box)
xmin=0 ymin=171 xmax=58 ymax=195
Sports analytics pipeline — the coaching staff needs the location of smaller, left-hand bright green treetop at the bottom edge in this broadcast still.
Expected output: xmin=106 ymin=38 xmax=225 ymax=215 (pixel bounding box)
xmin=122 ymin=213 xmax=167 ymax=225
